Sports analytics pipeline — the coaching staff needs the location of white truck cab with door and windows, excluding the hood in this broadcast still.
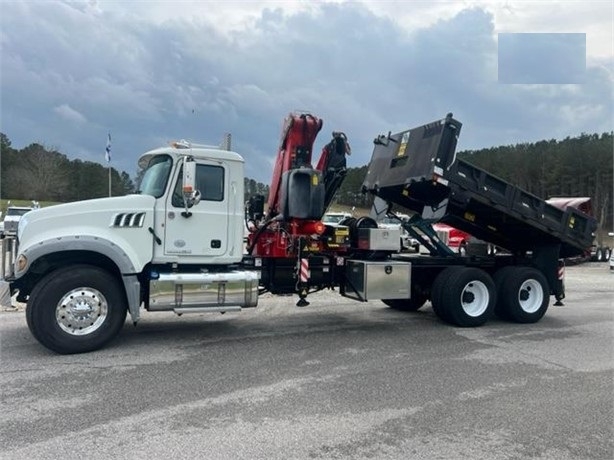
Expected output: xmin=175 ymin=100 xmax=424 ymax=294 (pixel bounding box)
xmin=138 ymin=143 xmax=244 ymax=265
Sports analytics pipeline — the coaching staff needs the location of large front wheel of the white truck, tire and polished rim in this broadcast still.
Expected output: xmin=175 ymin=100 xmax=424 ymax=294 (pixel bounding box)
xmin=26 ymin=265 xmax=127 ymax=354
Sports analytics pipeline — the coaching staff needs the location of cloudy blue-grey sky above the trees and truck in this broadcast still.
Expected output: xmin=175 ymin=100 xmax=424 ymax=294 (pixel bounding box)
xmin=0 ymin=0 xmax=614 ymax=182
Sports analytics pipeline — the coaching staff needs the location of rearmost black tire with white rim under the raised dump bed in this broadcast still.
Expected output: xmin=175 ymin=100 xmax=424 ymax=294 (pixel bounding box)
xmin=497 ymin=267 xmax=550 ymax=323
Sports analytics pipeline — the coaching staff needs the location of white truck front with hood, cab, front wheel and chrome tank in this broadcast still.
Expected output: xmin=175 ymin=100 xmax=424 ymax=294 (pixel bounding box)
xmin=0 ymin=142 xmax=258 ymax=353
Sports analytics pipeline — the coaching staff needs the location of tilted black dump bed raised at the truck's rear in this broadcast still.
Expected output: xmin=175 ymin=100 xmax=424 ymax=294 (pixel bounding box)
xmin=363 ymin=114 xmax=597 ymax=257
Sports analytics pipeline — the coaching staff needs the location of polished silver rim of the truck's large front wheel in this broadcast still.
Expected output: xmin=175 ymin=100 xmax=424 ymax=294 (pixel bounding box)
xmin=55 ymin=287 xmax=109 ymax=335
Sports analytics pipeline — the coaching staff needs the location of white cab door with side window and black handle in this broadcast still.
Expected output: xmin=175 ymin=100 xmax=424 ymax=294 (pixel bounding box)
xmin=164 ymin=160 xmax=229 ymax=263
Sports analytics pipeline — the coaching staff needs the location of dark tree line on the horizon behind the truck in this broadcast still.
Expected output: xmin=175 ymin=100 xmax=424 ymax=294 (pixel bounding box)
xmin=0 ymin=132 xmax=614 ymax=230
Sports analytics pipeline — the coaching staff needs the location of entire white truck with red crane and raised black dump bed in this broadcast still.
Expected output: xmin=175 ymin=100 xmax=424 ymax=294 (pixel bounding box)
xmin=3 ymin=114 xmax=596 ymax=353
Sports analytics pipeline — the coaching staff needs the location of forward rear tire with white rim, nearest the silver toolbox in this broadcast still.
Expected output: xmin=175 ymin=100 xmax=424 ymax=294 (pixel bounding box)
xmin=433 ymin=267 xmax=497 ymax=327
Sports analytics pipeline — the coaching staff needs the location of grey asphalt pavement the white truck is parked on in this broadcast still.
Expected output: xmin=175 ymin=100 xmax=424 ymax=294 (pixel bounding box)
xmin=0 ymin=263 xmax=614 ymax=460
